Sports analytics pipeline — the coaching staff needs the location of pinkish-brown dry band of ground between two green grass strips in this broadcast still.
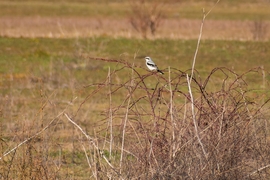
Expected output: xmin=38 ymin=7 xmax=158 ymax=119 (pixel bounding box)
xmin=0 ymin=17 xmax=270 ymax=40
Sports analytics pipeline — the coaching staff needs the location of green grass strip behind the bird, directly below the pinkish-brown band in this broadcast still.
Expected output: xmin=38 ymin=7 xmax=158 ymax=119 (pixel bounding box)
xmin=0 ymin=37 xmax=270 ymax=76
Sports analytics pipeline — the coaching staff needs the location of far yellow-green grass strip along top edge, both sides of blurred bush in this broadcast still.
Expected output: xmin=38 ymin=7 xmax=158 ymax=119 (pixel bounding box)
xmin=0 ymin=0 xmax=270 ymax=20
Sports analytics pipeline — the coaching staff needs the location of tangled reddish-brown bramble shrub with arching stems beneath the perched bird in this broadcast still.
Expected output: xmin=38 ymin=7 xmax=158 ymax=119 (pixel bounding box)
xmin=76 ymin=58 xmax=270 ymax=179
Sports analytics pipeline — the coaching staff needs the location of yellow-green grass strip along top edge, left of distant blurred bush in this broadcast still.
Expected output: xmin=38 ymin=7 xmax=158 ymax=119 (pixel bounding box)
xmin=0 ymin=1 xmax=128 ymax=17
